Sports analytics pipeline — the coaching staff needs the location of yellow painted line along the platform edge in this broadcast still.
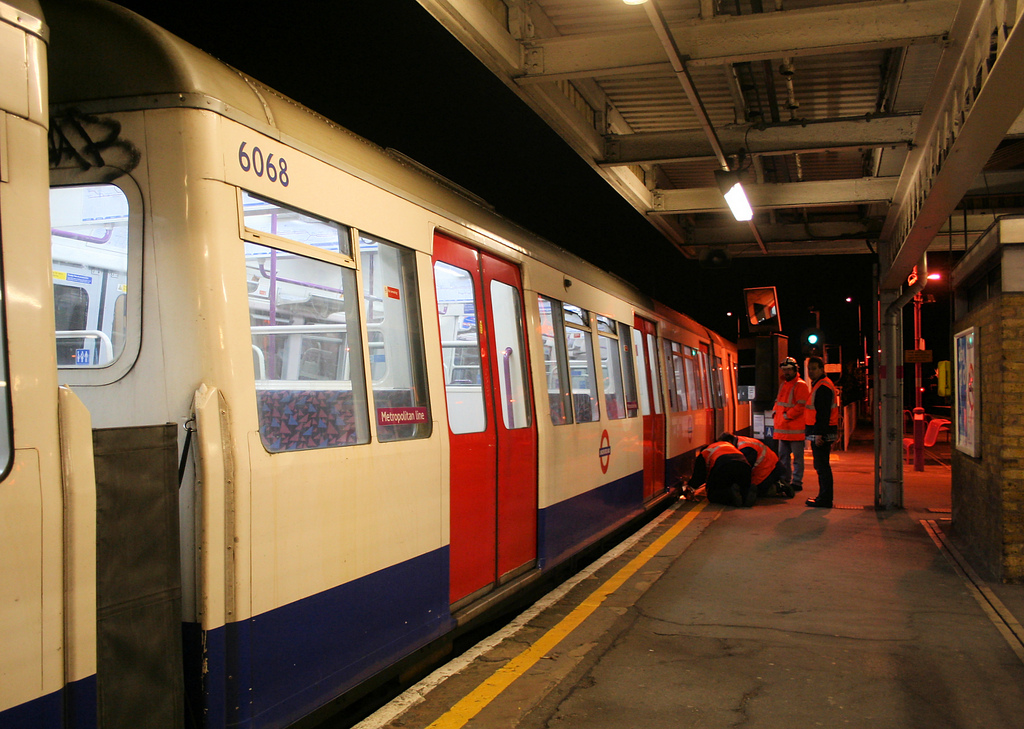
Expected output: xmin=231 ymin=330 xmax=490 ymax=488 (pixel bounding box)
xmin=428 ymin=502 xmax=708 ymax=729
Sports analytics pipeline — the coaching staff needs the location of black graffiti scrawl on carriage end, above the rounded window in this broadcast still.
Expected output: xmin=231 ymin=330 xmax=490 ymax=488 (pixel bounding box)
xmin=50 ymin=110 xmax=141 ymax=182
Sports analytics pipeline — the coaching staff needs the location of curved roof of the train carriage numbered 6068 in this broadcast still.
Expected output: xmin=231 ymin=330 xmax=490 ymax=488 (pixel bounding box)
xmin=41 ymin=0 xmax=654 ymax=311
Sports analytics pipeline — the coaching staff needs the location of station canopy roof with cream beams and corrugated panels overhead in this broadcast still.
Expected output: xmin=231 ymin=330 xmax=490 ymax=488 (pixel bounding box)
xmin=419 ymin=0 xmax=1024 ymax=289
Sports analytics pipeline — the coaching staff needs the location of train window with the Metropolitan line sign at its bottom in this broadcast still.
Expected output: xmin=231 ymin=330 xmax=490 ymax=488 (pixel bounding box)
xmin=359 ymin=233 xmax=430 ymax=441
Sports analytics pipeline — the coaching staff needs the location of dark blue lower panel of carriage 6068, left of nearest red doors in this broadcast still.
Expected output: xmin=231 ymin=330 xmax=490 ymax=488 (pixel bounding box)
xmin=184 ymin=547 xmax=453 ymax=729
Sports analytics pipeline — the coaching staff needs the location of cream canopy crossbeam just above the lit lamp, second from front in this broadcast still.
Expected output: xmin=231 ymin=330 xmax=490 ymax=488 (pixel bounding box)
xmin=599 ymin=115 xmax=918 ymax=167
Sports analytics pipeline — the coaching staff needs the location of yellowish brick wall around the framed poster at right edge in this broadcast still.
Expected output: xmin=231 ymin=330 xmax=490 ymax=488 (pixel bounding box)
xmin=952 ymin=293 xmax=1024 ymax=582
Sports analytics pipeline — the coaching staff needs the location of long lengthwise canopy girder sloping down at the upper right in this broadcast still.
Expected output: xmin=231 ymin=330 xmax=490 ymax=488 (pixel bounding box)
xmin=881 ymin=0 xmax=1024 ymax=290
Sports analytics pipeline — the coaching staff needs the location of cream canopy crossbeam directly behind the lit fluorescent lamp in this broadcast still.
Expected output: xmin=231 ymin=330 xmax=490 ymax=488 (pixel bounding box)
xmin=651 ymin=177 xmax=896 ymax=214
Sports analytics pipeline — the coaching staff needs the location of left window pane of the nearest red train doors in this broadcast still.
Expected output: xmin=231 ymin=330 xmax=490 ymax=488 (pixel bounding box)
xmin=434 ymin=261 xmax=487 ymax=433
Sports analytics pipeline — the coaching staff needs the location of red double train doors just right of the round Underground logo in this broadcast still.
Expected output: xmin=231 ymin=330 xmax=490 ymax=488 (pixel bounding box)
xmin=633 ymin=316 xmax=665 ymax=501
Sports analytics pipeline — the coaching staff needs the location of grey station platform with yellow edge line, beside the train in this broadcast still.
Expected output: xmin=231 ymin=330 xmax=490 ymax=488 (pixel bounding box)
xmin=356 ymin=431 xmax=1024 ymax=729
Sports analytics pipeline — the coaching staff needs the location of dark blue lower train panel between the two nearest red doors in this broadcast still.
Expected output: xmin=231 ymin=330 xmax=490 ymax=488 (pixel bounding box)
xmin=537 ymin=471 xmax=643 ymax=567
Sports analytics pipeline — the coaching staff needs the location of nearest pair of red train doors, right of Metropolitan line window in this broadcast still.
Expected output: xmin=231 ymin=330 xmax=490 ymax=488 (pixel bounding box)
xmin=433 ymin=234 xmax=537 ymax=603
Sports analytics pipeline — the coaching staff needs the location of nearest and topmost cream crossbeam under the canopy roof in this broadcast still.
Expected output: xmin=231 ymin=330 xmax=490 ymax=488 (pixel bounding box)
xmin=520 ymin=0 xmax=958 ymax=84
